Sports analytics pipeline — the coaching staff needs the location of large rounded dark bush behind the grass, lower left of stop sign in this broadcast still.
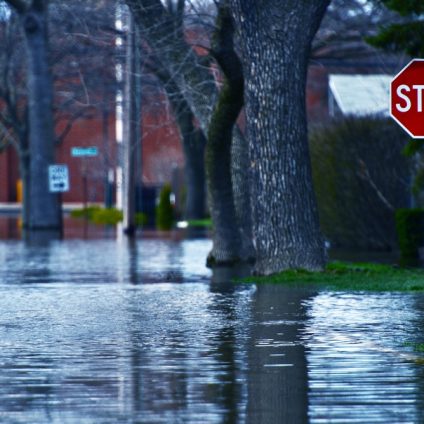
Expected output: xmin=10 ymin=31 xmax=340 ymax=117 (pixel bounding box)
xmin=310 ymin=117 xmax=411 ymax=251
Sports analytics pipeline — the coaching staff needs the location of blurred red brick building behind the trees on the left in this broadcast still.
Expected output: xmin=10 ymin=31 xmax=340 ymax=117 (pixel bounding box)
xmin=0 ymin=94 xmax=184 ymax=203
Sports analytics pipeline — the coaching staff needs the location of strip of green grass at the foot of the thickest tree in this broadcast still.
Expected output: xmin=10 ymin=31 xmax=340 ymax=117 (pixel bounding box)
xmin=243 ymin=262 xmax=424 ymax=292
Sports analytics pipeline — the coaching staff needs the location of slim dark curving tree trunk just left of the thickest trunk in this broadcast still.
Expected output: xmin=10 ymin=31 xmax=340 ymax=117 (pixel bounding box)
xmin=206 ymin=3 xmax=252 ymax=266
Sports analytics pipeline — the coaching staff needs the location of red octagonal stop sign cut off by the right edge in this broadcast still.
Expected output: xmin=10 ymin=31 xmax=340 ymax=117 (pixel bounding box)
xmin=390 ymin=59 xmax=424 ymax=138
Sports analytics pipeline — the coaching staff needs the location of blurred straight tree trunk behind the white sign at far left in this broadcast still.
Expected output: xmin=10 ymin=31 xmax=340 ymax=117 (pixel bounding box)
xmin=20 ymin=1 xmax=62 ymax=231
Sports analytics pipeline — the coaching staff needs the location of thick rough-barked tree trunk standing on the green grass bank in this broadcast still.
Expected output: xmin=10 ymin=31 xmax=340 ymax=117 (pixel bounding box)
xmin=231 ymin=0 xmax=329 ymax=274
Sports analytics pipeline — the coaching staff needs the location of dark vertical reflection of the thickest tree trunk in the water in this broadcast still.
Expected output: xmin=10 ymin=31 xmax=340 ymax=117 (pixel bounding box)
xmin=247 ymin=285 xmax=312 ymax=423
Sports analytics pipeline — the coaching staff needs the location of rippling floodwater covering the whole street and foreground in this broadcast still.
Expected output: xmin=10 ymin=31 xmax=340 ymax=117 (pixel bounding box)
xmin=0 ymin=217 xmax=424 ymax=424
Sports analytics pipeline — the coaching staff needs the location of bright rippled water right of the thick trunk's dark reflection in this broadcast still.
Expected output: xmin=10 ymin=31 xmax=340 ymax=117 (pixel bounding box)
xmin=304 ymin=293 xmax=424 ymax=423
